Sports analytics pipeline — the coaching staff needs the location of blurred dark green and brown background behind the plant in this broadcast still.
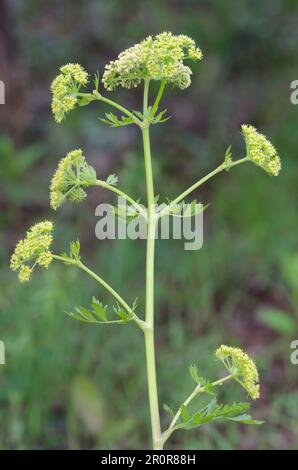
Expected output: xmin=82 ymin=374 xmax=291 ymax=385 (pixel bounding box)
xmin=0 ymin=0 xmax=298 ymax=449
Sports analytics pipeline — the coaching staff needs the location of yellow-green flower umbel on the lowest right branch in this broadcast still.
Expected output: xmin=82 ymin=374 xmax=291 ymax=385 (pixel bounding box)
xmin=215 ymin=345 xmax=260 ymax=400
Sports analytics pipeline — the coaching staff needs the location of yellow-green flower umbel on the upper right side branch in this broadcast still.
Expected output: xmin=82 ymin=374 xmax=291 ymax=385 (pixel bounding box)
xmin=241 ymin=124 xmax=281 ymax=176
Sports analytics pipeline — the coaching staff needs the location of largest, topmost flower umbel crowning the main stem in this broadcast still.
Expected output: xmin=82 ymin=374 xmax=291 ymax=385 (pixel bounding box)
xmin=102 ymin=32 xmax=203 ymax=90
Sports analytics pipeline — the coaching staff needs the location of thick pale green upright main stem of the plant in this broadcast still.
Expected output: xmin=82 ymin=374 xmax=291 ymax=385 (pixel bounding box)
xmin=142 ymin=81 xmax=161 ymax=449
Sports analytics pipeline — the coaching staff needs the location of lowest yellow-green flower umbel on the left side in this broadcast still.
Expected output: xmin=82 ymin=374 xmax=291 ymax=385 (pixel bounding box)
xmin=10 ymin=220 xmax=53 ymax=282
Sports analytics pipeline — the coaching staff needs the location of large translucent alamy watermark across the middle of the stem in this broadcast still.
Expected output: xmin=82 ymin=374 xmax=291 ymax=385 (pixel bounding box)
xmin=95 ymin=198 xmax=204 ymax=251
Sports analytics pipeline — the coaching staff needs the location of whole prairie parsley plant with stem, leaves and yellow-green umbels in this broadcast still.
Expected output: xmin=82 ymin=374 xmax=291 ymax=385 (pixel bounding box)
xmin=11 ymin=32 xmax=281 ymax=449
